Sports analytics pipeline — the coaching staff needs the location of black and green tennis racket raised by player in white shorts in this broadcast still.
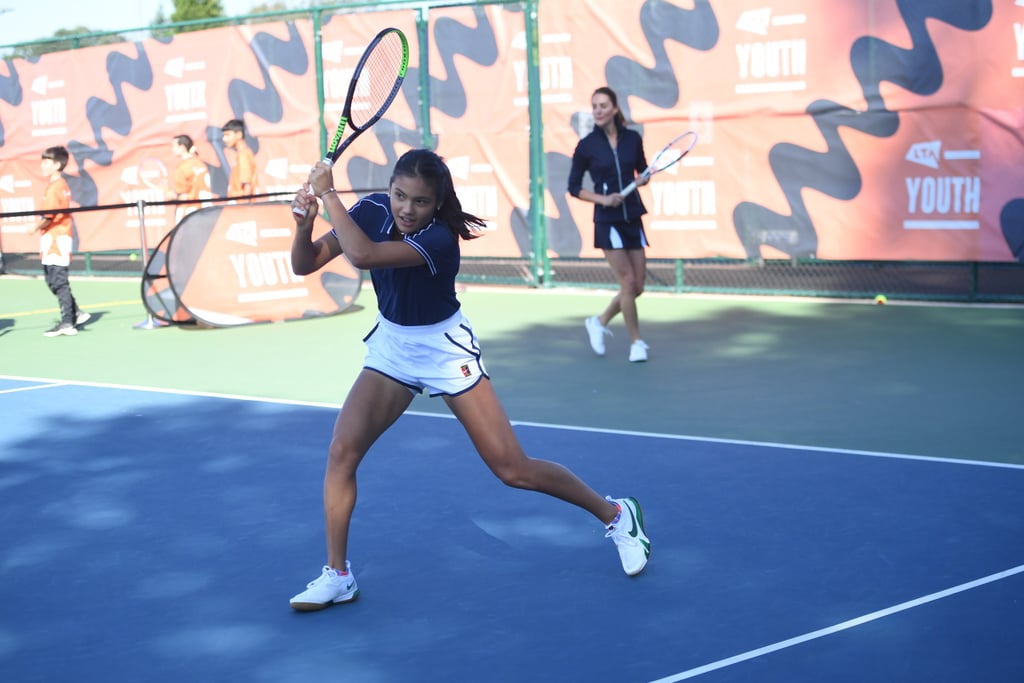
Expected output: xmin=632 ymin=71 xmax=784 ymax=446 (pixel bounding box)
xmin=293 ymin=29 xmax=409 ymax=216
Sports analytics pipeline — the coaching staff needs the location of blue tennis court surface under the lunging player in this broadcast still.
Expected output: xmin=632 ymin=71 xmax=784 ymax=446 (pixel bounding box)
xmin=0 ymin=378 xmax=1024 ymax=682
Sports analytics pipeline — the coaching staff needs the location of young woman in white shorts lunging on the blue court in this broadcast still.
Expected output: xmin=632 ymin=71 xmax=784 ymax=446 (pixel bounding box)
xmin=291 ymin=150 xmax=650 ymax=611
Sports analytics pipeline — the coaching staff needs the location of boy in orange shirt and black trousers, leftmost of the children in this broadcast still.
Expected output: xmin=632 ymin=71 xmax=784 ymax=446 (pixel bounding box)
xmin=36 ymin=145 xmax=92 ymax=337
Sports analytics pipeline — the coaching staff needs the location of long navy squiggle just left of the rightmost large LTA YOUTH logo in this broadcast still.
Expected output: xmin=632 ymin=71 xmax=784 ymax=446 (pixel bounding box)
xmin=732 ymin=0 xmax=992 ymax=259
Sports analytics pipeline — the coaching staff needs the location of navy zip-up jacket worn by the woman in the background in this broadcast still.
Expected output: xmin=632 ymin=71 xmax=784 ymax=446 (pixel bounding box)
xmin=569 ymin=120 xmax=647 ymax=223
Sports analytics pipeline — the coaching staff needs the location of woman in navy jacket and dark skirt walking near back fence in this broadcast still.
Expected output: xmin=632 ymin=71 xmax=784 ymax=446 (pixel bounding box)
xmin=569 ymin=87 xmax=648 ymax=362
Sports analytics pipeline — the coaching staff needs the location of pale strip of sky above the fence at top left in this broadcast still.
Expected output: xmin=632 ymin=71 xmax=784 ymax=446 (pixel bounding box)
xmin=0 ymin=0 xmax=260 ymax=45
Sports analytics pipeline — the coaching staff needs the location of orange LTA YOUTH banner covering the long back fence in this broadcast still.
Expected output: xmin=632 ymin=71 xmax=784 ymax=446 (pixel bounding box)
xmin=0 ymin=0 xmax=1024 ymax=261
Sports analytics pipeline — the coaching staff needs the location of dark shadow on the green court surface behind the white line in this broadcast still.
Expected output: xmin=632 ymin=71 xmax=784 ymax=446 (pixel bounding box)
xmin=446 ymin=300 xmax=1024 ymax=464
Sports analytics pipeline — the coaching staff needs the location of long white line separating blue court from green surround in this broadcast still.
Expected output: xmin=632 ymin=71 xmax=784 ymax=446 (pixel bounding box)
xmin=0 ymin=375 xmax=1024 ymax=470
